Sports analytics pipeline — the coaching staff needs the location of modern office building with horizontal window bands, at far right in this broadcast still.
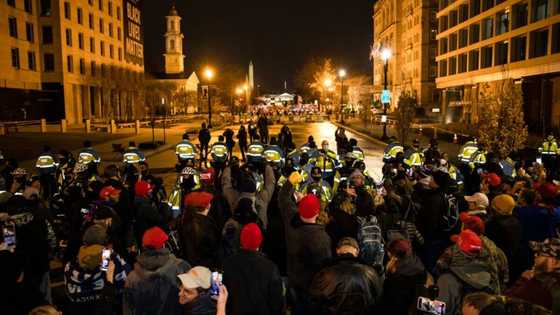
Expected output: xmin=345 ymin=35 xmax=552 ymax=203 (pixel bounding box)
xmin=436 ymin=0 xmax=560 ymax=131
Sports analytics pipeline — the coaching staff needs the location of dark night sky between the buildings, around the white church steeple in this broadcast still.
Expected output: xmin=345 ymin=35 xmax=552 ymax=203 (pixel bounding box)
xmin=143 ymin=0 xmax=373 ymax=92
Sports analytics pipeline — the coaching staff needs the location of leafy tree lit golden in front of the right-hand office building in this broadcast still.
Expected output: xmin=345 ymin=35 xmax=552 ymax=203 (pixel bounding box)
xmin=478 ymin=80 xmax=528 ymax=158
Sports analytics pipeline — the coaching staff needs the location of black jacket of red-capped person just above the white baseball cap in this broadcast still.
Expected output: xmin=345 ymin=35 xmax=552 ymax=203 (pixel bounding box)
xmin=179 ymin=213 xmax=220 ymax=269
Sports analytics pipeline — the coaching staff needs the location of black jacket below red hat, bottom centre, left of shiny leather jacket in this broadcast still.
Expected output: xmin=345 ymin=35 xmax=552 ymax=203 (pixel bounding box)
xmin=224 ymin=250 xmax=284 ymax=315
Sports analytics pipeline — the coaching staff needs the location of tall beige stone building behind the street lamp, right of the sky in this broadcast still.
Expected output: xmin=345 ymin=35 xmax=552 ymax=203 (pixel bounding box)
xmin=372 ymin=0 xmax=438 ymax=112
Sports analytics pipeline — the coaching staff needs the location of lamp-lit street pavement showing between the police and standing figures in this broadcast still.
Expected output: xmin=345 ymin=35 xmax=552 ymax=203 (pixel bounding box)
xmin=148 ymin=122 xmax=384 ymax=191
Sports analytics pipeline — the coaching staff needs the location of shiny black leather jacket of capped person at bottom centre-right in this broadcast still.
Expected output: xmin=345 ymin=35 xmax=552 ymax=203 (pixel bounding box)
xmin=309 ymin=255 xmax=382 ymax=315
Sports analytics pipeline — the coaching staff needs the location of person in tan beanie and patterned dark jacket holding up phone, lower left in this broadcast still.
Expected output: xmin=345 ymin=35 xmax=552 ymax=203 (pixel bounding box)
xmin=64 ymin=224 xmax=131 ymax=315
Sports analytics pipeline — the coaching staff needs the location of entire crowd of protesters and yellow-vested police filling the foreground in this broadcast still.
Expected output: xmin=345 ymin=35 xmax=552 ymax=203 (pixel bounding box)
xmin=0 ymin=116 xmax=560 ymax=315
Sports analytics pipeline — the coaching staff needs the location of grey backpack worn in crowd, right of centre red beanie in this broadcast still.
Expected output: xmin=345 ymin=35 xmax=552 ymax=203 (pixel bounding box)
xmin=357 ymin=215 xmax=385 ymax=266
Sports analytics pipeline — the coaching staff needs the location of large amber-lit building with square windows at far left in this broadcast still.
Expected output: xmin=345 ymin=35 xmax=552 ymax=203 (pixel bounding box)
xmin=0 ymin=0 xmax=145 ymax=124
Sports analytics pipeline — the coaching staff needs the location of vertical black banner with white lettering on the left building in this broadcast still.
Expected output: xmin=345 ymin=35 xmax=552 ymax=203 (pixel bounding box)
xmin=123 ymin=0 xmax=144 ymax=65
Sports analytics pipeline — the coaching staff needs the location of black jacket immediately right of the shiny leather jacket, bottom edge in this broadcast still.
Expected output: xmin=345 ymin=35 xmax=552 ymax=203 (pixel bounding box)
xmin=380 ymin=256 xmax=427 ymax=315
